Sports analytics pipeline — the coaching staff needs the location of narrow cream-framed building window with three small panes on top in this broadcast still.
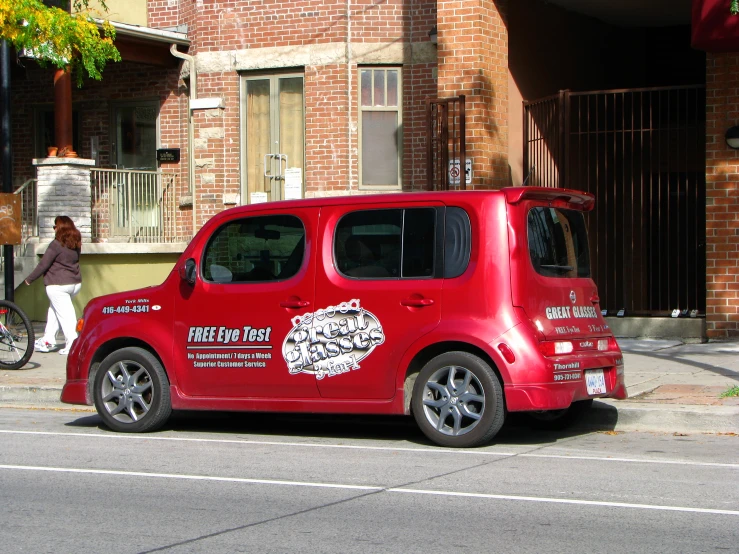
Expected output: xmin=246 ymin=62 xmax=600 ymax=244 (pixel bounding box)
xmin=359 ymin=67 xmax=403 ymax=189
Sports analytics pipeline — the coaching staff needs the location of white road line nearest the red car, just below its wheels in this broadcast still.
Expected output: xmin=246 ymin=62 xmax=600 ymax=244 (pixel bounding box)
xmin=0 ymin=429 xmax=739 ymax=469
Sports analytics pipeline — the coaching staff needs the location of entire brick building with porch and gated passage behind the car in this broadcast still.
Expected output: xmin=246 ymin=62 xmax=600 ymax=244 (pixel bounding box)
xmin=0 ymin=0 xmax=739 ymax=338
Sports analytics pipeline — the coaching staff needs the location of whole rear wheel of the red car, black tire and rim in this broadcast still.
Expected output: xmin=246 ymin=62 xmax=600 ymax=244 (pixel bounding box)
xmin=411 ymin=352 xmax=505 ymax=448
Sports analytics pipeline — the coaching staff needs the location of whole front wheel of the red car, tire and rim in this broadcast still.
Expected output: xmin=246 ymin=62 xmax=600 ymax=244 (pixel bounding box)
xmin=93 ymin=347 xmax=172 ymax=433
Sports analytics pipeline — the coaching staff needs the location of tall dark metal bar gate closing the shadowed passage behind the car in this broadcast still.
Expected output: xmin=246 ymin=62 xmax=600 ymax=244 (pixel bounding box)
xmin=524 ymin=86 xmax=706 ymax=316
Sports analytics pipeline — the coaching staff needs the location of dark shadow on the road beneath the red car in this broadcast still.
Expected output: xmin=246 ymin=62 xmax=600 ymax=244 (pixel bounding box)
xmin=60 ymin=404 xmax=618 ymax=446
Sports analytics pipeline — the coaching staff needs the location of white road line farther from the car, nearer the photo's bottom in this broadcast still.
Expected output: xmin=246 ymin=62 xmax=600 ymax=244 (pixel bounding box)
xmin=0 ymin=465 xmax=739 ymax=516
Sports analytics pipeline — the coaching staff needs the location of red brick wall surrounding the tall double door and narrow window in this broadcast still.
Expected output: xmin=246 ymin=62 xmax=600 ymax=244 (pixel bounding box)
xmin=149 ymin=0 xmax=437 ymax=207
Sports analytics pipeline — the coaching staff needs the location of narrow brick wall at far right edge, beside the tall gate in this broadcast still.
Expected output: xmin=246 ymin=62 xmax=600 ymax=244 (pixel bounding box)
xmin=706 ymin=53 xmax=739 ymax=339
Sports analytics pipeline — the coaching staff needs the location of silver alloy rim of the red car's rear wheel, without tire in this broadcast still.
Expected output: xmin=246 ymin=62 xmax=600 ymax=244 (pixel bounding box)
xmin=423 ymin=366 xmax=485 ymax=437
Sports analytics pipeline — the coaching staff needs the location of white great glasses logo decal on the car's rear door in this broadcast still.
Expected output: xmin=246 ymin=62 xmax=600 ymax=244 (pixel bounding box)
xmin=282 ymin=299 xmax=385 ymax=379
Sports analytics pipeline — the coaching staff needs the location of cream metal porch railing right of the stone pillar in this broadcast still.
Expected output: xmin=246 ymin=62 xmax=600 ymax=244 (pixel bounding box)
xmin=90 ymin=168 xmax=189 ymax=243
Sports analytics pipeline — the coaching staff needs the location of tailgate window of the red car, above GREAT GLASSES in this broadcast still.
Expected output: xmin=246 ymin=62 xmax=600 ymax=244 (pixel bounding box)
xmin=528 ymin=207 xmax=590 ymax=277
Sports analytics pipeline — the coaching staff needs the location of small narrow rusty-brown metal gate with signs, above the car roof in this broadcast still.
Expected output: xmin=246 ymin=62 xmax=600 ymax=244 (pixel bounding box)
xmin=426 ymin=95 xmax=467 ymax=190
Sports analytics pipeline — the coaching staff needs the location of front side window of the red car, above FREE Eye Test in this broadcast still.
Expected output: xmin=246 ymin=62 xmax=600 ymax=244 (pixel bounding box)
xmin=202 ymin=211 xmax=305 ymax=283
